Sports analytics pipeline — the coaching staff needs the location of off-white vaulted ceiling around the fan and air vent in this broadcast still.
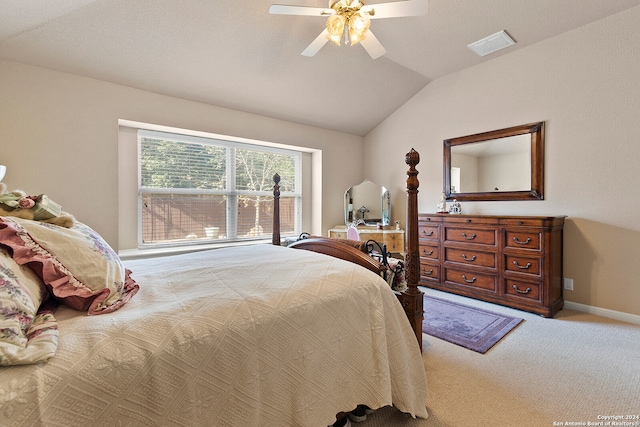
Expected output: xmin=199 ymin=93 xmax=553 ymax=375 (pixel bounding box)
xmin=0 ymin=0 xmax=640 ymax=135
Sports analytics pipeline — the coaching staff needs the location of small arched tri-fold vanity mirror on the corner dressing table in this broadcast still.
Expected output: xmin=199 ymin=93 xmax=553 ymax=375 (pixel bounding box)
xmin=344 ymin=180 xmax=391 ymax=225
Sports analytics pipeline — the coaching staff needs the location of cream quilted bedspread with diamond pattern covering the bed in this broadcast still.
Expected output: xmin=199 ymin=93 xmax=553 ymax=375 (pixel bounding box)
xmin=0 ymin=245 xmax=427 ymax=427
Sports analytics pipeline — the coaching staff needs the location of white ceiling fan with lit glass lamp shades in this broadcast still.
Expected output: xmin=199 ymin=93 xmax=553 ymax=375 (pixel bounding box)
xmin=269 ymin=0 xmax=429 ymax=59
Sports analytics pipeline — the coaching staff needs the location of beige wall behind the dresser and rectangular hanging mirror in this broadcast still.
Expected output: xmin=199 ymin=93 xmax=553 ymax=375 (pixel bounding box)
xmin=365 ymin=7 xmax=640 ymax=315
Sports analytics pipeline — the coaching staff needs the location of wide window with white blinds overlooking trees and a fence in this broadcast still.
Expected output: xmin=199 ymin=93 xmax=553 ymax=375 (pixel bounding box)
xmin=138 ymin=130 xmax=302 ymax=247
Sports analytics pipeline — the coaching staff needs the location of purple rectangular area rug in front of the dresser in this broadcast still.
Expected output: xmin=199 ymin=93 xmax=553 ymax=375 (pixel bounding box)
xmin=422 ymin=295 xmax=523 ymax=354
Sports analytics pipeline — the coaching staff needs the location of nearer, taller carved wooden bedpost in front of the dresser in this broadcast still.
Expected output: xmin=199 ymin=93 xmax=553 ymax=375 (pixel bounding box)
xmin=401 ymin=148 xmax=424 ymax=351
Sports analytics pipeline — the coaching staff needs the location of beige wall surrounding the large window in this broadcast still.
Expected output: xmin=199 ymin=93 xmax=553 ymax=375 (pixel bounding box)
xmin=0 ymin=61 xmax=363 ymax=249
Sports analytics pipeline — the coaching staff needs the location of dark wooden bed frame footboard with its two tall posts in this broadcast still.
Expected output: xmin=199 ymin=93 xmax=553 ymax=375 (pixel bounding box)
xmin=272 ymin=148 xmax=424 ymax=351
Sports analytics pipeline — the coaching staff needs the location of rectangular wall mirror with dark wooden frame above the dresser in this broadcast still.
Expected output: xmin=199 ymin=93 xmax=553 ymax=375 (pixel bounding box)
xmin=443 ymin=122 xmax=544 ymax=201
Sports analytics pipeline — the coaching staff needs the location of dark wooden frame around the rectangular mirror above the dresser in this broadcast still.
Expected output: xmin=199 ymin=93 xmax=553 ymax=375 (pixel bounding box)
xmin=443 ymin=122 xmax=544 ymax=201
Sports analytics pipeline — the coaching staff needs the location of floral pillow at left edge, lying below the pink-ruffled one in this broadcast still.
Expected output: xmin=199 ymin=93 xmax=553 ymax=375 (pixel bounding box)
xmin=0 ymin=247 xmax=58 ymax=366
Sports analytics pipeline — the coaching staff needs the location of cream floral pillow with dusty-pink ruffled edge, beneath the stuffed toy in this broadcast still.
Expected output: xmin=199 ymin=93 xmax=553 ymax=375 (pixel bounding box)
xmin=0 ymin=217 xmax=138 ymax=314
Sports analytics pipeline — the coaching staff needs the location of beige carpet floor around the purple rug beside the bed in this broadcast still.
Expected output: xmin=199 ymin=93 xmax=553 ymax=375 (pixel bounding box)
xmin=352 ymin=288 xmax=640 ymax=427
